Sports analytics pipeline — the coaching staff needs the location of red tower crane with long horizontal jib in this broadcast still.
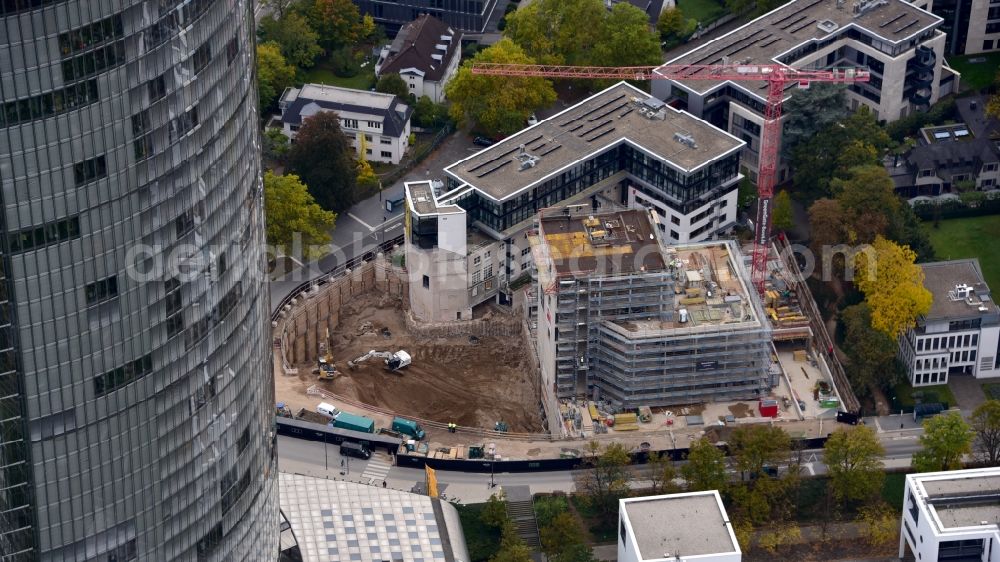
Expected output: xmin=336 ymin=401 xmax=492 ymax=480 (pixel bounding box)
xmin=472 ymin=63 xmax=870 ymax=294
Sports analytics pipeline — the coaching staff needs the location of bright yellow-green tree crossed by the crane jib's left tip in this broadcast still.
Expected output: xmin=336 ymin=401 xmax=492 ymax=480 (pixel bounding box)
xmin=445 ymin=38 xmax=556 ymax=136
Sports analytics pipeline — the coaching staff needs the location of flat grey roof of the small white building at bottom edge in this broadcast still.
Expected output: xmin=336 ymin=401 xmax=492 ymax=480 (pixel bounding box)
xmin=621 ymin=491 xmax=740 ymax=560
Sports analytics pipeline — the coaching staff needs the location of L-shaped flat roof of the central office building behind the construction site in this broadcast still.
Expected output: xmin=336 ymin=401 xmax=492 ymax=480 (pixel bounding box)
xmin=445 ymin=82 xmax=744 ymax=201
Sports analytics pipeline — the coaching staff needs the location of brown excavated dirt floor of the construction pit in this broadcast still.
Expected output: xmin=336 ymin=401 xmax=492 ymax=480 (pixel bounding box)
xmin=299 ymin=293 xmax=543 ymax=432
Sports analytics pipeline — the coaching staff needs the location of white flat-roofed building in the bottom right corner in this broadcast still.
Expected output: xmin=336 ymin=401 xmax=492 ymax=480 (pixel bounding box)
xmin=899 ymin=467 xmax=1000 ymax=562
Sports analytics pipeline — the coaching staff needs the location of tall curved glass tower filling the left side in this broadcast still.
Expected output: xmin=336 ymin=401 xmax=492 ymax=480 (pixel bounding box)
xmin=0 ymin=0 xmax=279 ymax=562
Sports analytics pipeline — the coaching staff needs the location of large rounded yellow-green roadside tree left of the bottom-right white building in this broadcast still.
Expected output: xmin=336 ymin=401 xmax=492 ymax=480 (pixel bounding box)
xmin=823 ymin=425 xmax=885 ymax=506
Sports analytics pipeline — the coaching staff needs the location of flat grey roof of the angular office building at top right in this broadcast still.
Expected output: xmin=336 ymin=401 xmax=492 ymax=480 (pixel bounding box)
xmin=667 ymin=0 xmax=942 ymax=94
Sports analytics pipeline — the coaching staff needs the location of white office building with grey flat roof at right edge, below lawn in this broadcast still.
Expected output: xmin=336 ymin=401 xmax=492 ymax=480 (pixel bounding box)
xmin=899 ymin=258 xmax=1000 ymax=386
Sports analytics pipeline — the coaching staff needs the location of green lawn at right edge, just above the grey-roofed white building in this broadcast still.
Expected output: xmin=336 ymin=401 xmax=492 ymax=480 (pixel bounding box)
xmin=924 ymin=216 xmax=1000 ymax=288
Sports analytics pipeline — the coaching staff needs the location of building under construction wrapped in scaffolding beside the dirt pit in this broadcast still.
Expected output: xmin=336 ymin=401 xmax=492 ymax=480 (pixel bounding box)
xmin=530 ymin=206 xmax=777 ymax=409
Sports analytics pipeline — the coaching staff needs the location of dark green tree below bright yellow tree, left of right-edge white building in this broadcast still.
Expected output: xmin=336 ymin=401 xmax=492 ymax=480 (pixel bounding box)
xmin=840 ymin=302 xmax=900 ymax=391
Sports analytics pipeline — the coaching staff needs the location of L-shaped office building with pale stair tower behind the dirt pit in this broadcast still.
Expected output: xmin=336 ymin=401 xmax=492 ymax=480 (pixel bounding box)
xmin=406 ymin=82 xmax=744 ymax=321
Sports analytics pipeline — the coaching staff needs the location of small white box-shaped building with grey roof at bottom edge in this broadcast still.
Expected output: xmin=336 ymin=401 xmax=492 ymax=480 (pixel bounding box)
xmin=618 ymin=490 xmax=743 ymax=562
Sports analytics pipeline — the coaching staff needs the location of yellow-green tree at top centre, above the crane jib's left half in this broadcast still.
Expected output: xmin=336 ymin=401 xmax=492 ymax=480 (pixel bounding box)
xmin=504 ymin=0 xmax=607 ymax=65
